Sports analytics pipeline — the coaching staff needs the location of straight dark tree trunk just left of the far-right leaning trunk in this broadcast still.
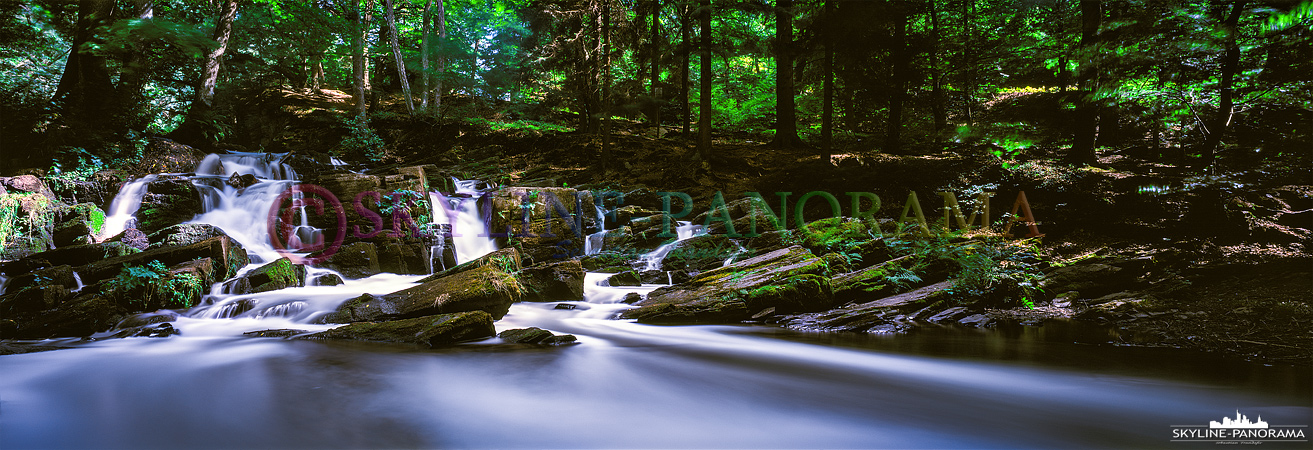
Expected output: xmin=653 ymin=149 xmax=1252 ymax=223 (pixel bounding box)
xmin=1066 ymin=0 xmax=1103 ymax=164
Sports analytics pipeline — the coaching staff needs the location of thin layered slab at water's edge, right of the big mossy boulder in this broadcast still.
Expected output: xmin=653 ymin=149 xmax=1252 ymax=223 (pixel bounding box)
xmin=783 ymin=281 xmax=953 ymax=333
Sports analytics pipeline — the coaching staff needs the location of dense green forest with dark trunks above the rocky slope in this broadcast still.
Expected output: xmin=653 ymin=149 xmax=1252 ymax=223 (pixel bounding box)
xmin=0 ymin=0 xmax=1313 ymax=176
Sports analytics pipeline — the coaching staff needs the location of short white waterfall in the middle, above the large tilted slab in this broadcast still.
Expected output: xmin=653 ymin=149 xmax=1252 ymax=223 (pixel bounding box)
xmin=429 ymin=180 xmax=496 ymax=264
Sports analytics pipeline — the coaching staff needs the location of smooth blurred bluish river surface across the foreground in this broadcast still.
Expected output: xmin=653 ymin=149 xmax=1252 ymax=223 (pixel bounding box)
xmin=0 ymin=302 xmax=1313 ymax=449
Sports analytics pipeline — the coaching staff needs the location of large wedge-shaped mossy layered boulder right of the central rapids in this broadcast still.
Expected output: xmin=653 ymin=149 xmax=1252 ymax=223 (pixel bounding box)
xmin=622 ymin=245 xmax=834 ymax=323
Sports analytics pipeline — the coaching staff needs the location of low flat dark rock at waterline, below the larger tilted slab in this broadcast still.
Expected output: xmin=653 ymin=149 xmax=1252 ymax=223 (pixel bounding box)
xmin=295 ymin=311 xmax=496 ymax=348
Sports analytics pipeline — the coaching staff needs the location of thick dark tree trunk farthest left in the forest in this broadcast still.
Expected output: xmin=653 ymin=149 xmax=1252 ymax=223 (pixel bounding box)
xmin=54 ymin=0 xmax=114 ymax=133
